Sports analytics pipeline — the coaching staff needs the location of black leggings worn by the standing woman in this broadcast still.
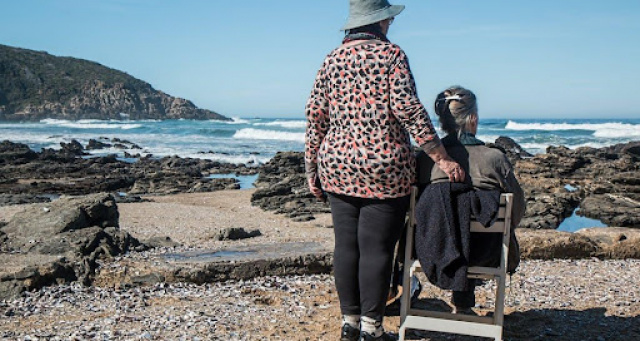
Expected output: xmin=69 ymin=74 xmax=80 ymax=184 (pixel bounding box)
xmin=328 ymin=193 xmax=409 ymax=321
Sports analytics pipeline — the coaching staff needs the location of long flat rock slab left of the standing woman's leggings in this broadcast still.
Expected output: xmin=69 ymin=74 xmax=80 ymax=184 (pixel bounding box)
xmin=94 ymin=242 xmax=333 ymax=286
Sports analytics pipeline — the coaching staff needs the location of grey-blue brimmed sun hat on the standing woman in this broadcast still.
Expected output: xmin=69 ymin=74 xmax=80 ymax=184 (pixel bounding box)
xmin=341 ymin=0 xmax=404 ymax=31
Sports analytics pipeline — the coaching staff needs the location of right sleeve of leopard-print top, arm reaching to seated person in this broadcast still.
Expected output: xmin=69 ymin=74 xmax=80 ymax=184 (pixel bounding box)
xmin=389 ymin=50 xmax=440 ymax=151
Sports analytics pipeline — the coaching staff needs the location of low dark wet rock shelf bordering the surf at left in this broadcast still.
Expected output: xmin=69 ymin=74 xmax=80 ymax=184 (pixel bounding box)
xmin=0 ymin=138 xmax=257 ymax=205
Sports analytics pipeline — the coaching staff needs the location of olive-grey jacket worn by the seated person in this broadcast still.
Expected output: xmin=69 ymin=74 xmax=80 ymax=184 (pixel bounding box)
xmin=416 ymin=133 xmax=525 ymax=290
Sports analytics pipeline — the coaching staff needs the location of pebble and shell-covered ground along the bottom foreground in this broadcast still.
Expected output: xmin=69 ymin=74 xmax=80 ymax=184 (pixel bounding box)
xmin=0 ymin=259 xmax=640 ymax=341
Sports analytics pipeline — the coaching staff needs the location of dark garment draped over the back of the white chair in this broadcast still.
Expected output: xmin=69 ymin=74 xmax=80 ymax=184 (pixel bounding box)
xmin=415 ymin=182 xmax=500 ymax=291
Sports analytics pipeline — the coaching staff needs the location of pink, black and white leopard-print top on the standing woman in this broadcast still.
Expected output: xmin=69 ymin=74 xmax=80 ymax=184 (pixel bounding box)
xmin=305 ymin=40 xmax=440 ymax=199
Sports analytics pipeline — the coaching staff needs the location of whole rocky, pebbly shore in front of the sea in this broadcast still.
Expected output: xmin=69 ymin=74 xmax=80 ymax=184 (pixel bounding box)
xmin=0 ymin=137 xmax=640 ymax=340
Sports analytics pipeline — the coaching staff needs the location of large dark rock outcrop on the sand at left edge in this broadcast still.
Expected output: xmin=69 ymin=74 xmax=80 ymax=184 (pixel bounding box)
xmin=0 ymin=194 xmax=144 ymax=299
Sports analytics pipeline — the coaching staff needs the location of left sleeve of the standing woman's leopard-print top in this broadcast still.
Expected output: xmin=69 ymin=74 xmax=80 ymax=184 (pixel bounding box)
xmin=305 ymin=62 xmax=329 ymax=164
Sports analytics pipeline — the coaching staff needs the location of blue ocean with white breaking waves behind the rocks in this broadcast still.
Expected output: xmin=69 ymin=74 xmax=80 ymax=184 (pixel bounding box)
xmin=0 ymin=116 xmax=640 ymax=165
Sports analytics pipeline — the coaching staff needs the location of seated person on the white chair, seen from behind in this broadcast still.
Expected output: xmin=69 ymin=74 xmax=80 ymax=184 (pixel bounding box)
xmin=418 ymin=86 xmax=525 ymax=312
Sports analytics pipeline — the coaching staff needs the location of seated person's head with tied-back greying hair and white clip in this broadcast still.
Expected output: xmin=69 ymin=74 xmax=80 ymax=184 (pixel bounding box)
xmin=435 ymin=86 xmax=478 ymax=136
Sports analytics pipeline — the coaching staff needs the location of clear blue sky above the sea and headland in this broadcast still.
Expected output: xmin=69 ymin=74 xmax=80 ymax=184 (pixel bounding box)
xmin=0 ymin=0 xmax=640 ymax=118
